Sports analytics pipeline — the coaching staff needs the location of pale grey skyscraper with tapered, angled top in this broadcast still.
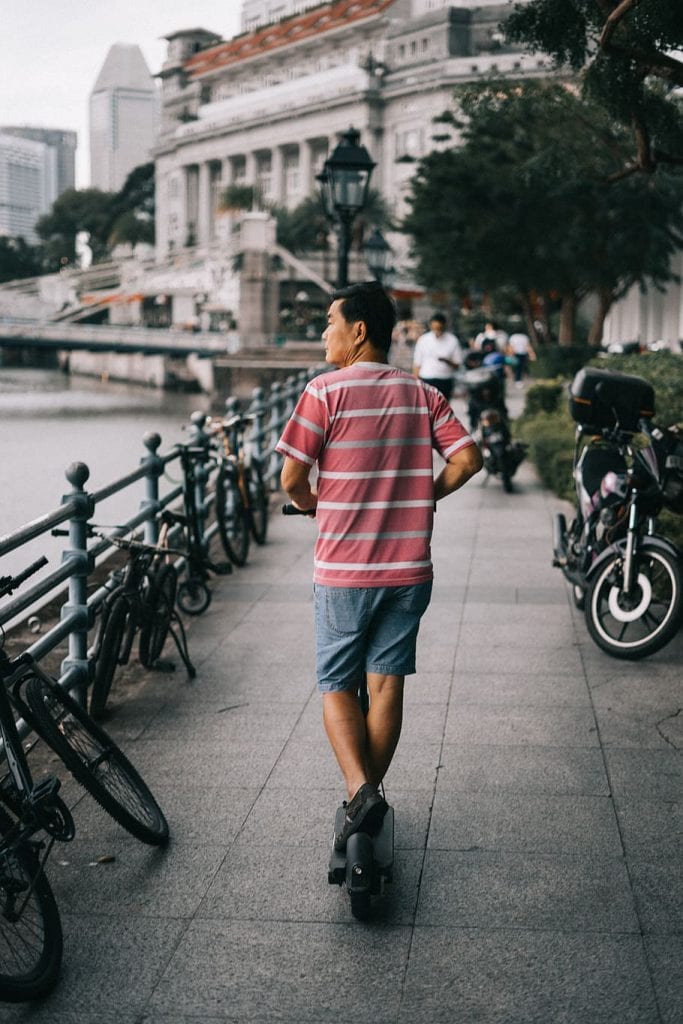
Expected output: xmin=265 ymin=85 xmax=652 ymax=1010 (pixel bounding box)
xmin=90 ymin=43 xmax=158 ymax=191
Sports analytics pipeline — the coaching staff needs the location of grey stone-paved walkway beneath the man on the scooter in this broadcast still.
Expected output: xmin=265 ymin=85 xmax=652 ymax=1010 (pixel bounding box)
xmin=0 ymin=401 xmax=683 ymax=1024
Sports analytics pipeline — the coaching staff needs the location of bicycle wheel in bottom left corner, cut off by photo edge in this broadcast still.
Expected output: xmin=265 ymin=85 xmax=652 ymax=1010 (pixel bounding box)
xmin=0 ymin=808 xmax=62 ymax=1002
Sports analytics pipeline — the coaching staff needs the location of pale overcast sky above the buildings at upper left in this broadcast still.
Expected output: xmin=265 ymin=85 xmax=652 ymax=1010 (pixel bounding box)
xmin=0 ymin=0 xmax=242 ymax=188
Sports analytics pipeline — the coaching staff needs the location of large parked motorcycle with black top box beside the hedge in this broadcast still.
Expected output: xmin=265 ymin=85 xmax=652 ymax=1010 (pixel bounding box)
xmin=553 ymin=368 xmax=683 ymax=660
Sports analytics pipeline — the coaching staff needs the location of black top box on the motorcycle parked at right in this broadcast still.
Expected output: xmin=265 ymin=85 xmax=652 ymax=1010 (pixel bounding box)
xmin=569 ymin=367 xmax=654 ymax=432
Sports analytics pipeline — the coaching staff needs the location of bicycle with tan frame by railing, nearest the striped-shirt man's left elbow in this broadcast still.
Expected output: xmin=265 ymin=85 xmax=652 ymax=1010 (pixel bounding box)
xmin=203 ymin=413 xmax=269 ymax=565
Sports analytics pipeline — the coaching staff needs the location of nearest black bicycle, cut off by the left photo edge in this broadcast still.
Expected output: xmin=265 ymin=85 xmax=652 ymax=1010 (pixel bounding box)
xmin=0 ymin=558 xmax=169 ymax=1001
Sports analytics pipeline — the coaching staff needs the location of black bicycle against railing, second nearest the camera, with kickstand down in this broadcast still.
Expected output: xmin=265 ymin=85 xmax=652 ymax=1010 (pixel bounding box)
xmin=89 ymin=520 xmax=197 ymax=718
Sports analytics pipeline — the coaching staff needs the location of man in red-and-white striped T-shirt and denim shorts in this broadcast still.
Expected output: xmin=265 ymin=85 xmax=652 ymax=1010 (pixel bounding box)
xmin=276 ymin=282 xmax=482 ymax=850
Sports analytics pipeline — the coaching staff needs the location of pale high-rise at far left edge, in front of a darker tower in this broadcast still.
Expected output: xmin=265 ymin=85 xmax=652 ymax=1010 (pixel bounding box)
xmin=0 ymin=130 xmax=57 ymax=244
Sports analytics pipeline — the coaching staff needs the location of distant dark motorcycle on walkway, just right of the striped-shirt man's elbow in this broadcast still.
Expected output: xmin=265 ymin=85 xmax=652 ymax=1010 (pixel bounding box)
xmin=463 ymin=365 xmax=526 ymax=494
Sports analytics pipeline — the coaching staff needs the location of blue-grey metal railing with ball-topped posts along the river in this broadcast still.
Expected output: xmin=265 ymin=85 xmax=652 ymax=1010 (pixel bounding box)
xmin=0 ymin=367 xmax=321 ymax=727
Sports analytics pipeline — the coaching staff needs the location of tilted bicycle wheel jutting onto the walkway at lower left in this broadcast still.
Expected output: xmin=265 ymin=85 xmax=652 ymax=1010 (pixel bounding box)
xmin=26 ymin=675 xmax=168 ymax=846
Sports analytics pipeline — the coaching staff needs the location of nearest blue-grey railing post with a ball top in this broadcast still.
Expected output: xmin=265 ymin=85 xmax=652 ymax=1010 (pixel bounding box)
xmin=59 ymin=462 xmax=94 ymax=707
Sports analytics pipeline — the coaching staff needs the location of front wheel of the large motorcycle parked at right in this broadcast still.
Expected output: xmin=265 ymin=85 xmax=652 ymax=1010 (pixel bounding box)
xmin=585 ymin=542 xmax=682 ymax=660
